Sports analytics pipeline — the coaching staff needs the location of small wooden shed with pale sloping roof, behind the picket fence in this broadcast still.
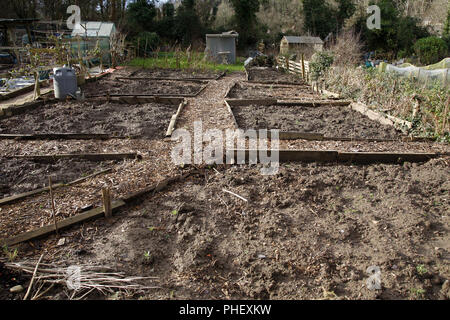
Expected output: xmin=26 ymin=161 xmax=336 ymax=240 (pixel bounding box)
xmin=280 ymin=36 xmax=323 ymax=60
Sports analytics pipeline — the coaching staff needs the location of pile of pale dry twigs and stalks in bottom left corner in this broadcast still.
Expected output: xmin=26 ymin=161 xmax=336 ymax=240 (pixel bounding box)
xmin=5 ymin=256 xmax=159 ymax=300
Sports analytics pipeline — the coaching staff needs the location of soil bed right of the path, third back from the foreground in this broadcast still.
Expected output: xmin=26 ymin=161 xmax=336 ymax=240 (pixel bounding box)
xmin=227 ymin=82 xmax=323 ymax=101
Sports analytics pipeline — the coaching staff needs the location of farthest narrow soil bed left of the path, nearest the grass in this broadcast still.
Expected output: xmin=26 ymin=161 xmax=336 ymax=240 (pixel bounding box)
xmin=131 ymin=69 xmax=222 ymax=80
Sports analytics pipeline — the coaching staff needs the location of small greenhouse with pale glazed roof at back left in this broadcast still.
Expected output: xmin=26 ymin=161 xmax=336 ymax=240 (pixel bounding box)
xmin=71 ymin=21 xmax=116 ymax=64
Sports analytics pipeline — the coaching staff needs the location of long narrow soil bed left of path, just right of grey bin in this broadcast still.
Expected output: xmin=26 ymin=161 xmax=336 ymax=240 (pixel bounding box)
xmin=83 ymin=77 xmax=203 ymax=97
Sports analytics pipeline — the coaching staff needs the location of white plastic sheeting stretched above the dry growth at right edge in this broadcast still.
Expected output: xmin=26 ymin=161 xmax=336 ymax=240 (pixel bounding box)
xmin=378 ymin=58 xmax=450 ymax=87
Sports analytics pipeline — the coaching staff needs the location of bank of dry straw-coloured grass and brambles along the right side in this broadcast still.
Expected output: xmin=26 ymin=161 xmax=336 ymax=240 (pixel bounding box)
xmin=326 ymin=66 xmax=450 ymax=141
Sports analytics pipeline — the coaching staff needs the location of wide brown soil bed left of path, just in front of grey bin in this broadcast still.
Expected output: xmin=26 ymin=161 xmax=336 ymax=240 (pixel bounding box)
xmin=0 ymin=102 xmax=178 ymax=139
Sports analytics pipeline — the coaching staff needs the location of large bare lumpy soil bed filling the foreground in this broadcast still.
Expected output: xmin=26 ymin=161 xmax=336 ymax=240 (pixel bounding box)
xmin=41 ymin=160 xmax=450 ymax=299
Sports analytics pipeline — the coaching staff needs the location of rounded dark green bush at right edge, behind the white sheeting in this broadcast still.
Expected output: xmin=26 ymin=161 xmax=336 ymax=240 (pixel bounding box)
xmin=414 ymin=37 xmax=447 ymax=65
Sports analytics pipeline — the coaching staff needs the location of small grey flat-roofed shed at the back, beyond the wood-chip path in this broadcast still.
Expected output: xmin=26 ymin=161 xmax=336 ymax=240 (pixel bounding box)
xmin=206 ymin=31 xmax=239 ymax=64
